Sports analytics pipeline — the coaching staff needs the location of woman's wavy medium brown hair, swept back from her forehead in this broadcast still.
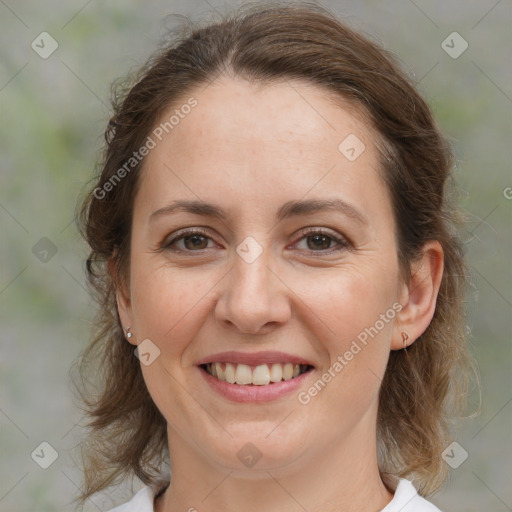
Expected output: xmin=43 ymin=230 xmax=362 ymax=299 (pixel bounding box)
xmin=75 ymin=2 xmax=471 ymax=502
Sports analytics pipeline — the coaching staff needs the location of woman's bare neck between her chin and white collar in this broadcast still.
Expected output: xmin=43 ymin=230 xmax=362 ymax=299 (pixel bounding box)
xmin=155 ymin=418 xmax=393 ymax=512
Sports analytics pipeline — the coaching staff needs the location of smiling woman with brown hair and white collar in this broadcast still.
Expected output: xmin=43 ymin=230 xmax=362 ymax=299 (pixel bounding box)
xmin=76 ymin=4 xmax=469 ymax=512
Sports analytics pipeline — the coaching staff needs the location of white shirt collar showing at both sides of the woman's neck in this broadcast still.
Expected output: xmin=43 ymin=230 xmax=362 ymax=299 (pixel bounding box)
xmin=109 ymin=478 xmax=441 ymax=512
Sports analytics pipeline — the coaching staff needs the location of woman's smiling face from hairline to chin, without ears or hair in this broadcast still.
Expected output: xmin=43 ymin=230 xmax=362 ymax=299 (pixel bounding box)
xmin=120 ymin=78 xmax=403 ymax=474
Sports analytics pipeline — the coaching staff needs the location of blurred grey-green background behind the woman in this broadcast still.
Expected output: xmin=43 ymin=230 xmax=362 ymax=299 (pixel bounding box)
xmin=0 ymin=0 xmax=512 ymax=512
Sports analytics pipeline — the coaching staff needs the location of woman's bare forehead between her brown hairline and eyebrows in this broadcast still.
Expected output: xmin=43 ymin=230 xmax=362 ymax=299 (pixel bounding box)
xmin=134 ymin=77 xmax=390 ymax=222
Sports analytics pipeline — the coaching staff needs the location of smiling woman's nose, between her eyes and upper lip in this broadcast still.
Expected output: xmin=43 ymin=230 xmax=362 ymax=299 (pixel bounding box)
xmin=215 ymin=251 xmax=291 ymax=334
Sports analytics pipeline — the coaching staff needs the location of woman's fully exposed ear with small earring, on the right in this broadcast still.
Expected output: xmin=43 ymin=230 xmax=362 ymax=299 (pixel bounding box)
xmin=391 ymin=240 xmax=444 ymax=350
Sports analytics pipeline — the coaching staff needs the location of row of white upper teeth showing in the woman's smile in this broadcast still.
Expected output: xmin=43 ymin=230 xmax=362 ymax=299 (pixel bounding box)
xmin=206 ymin=363 xmax=307 ymax=386
